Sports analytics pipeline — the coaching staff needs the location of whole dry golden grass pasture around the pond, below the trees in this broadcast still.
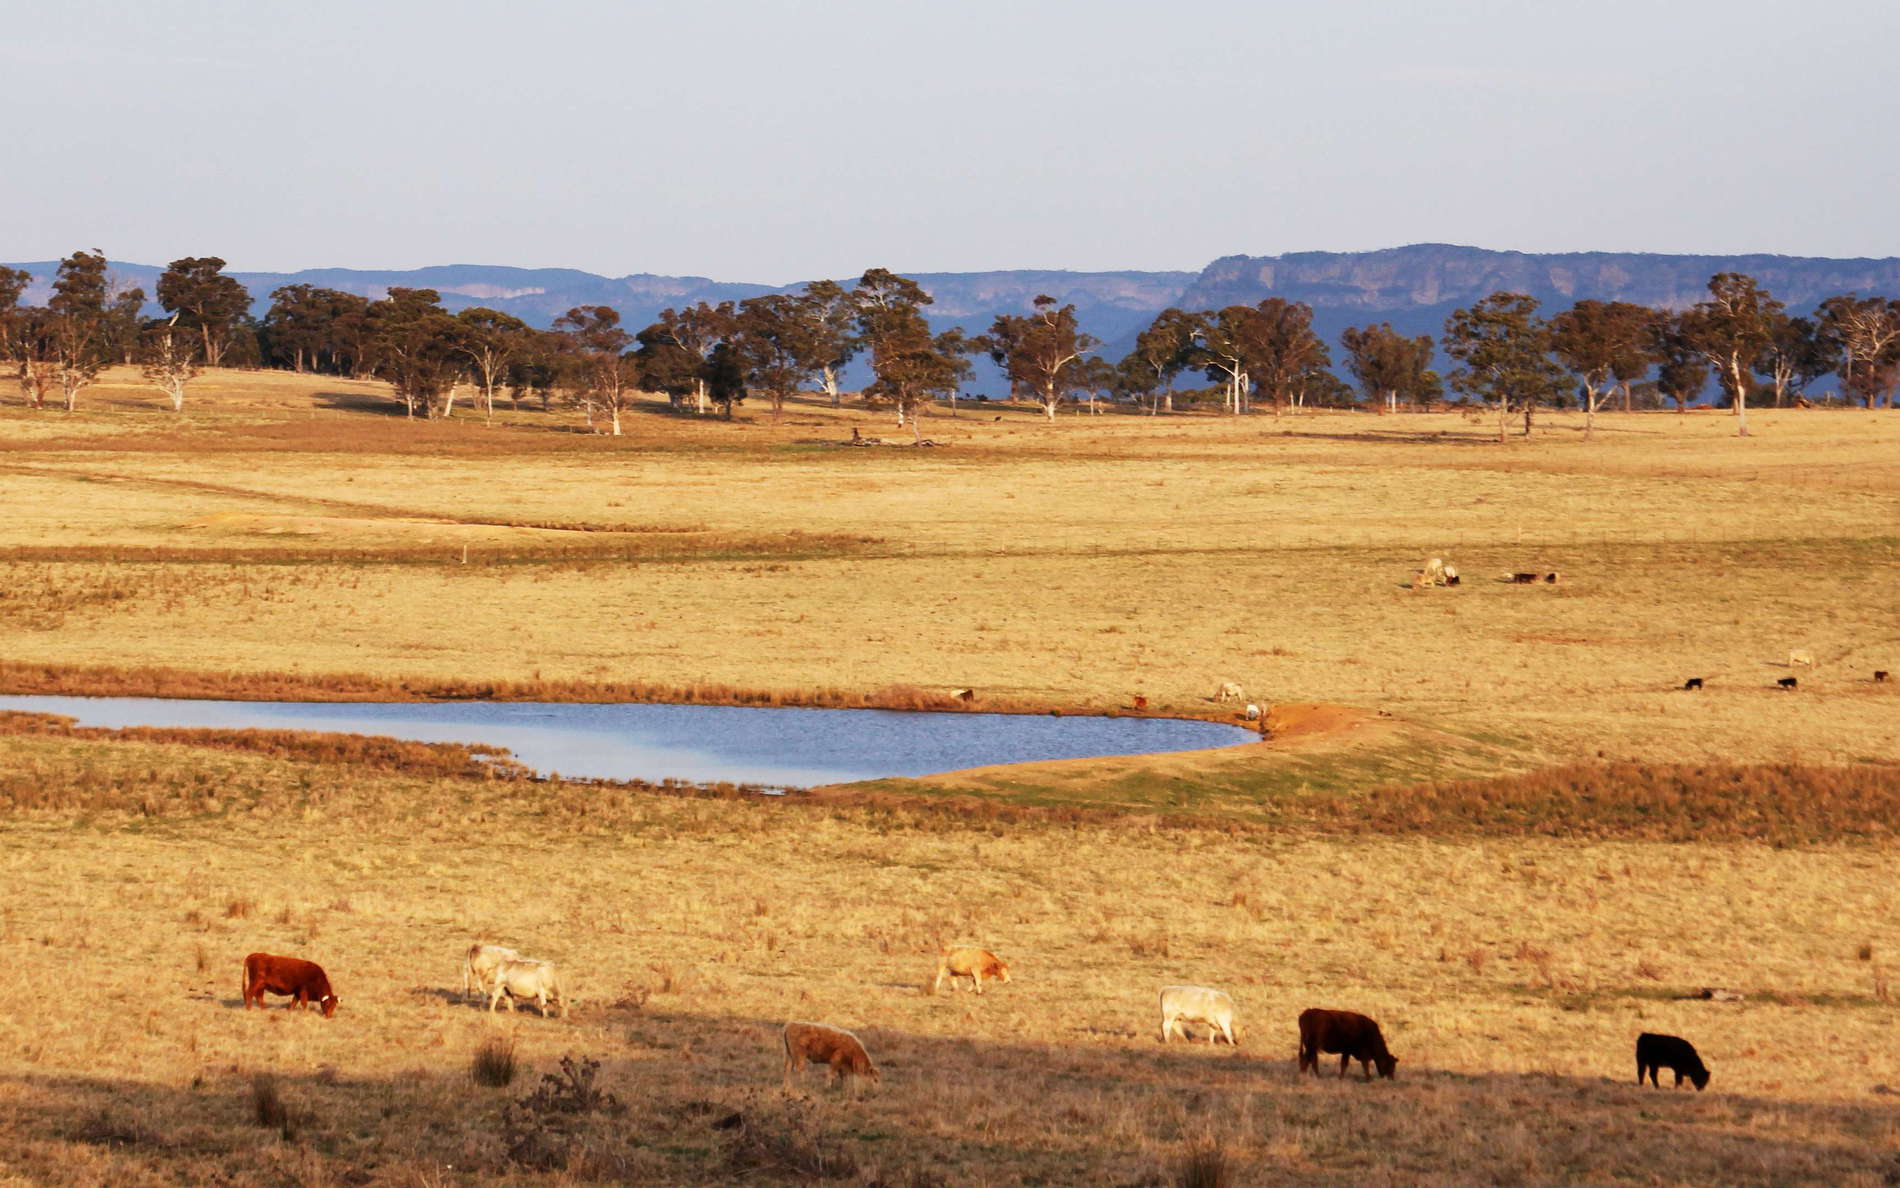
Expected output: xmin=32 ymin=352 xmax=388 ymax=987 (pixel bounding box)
xmin=0 ymin=373 xmax=1900 ymax=1184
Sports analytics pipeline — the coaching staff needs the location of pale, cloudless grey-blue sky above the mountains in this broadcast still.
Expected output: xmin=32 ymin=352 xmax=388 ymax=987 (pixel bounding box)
xmin=0 ymin=0 xmax=1900 ymax=283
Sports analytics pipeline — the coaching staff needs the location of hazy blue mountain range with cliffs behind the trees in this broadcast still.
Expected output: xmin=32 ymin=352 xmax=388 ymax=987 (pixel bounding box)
xmin=13 ymin=243 xmax=1900 ymax=370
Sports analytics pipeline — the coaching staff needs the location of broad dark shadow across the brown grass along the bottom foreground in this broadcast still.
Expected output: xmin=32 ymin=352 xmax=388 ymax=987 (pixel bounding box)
xmin=14 ymin=1004 xmax=1900 ymax=1184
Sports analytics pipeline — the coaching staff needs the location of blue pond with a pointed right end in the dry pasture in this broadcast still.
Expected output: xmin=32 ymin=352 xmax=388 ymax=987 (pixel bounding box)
xmin=0 ymin=696 xmax=1260 ymax=787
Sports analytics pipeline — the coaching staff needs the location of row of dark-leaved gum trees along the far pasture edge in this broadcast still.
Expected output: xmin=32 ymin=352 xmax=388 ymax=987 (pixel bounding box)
xmin=0 ymin=251 xmax=1900 ymax=437
